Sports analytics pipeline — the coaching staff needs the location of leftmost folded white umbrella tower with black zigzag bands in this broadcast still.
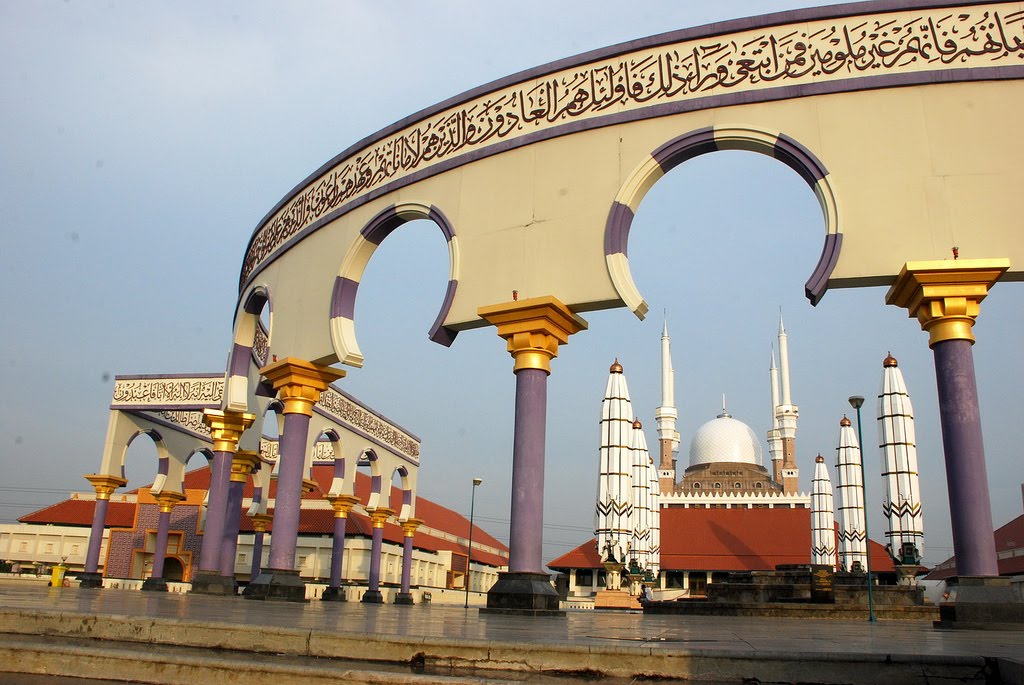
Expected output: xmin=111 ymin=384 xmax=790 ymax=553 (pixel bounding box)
xmin=594 ymin=359 xmax=633 ymax=573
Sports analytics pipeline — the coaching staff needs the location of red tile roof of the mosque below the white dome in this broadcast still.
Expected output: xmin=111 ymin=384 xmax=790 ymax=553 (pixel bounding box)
xmin=548 ymin=507 xmax=893 ymax=571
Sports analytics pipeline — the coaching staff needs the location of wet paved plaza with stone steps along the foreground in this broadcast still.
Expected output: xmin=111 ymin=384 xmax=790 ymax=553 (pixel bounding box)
xmin=0 ymin=582 xmax=1024 ymax=684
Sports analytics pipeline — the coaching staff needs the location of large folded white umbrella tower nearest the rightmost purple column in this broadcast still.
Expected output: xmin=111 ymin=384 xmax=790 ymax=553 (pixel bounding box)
xmin=879 ymin=354 xmax=925 ymax=565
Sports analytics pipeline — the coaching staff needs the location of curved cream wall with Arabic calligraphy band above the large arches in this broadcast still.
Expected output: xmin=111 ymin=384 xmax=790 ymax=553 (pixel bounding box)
xmin=240 ymin=3 xmax=1024 ymax=363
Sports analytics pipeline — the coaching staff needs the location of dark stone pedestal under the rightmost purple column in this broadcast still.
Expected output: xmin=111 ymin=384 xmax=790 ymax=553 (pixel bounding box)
xmin=935 ymin=575 xmax=1024 ymax=631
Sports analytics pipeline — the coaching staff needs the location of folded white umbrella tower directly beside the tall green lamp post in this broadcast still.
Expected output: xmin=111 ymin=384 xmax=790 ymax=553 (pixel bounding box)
xmin=836 ymin=417 xmax=867 ymax=572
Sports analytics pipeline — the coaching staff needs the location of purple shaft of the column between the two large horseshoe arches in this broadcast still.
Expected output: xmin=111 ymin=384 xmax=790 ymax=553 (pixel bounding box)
xmin=509 ymin=369 xmax=548 ymax=573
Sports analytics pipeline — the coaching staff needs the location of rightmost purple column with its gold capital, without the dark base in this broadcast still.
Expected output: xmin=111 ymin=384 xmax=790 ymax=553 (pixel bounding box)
xmin=886 ymin=259 xmax=1010 ymax=575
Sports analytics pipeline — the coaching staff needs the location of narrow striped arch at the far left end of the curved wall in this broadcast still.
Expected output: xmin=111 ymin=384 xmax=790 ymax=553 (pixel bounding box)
xmin=224 ymin=284 xmax=273 ymax=412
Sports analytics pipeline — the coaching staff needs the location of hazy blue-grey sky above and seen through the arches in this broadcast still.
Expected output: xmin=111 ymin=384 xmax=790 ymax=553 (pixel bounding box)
xmin=0 ymin=0 xmax=1024 ymax=564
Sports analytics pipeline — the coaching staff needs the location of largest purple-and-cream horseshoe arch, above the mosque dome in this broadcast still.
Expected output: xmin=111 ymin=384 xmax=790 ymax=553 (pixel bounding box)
xmin=604 ymin=126 xmax=843 ymax=318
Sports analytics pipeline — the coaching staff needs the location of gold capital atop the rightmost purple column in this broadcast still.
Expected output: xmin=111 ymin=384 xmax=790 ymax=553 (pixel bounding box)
xmin=886 ymin=259 xmax=1010 ymax=347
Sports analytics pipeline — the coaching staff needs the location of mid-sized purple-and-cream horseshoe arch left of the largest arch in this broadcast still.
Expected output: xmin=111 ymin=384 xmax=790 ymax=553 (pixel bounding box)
xmin=331 ymin=203 xmax=459 ymax=367
